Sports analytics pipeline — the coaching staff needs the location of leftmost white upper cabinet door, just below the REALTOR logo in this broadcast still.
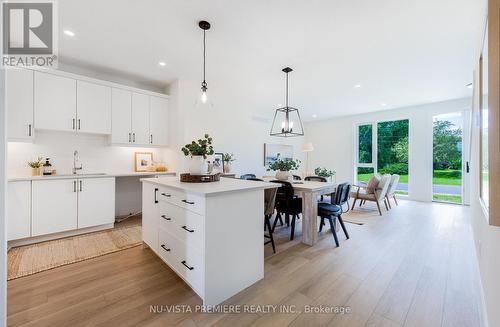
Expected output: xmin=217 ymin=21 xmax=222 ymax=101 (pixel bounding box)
xmin=5 ymin=69 xmax=33 ymax=140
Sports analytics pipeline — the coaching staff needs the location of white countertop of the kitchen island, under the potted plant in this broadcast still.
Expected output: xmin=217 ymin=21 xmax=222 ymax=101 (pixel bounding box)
xmin=141 ymin=176 xmax=280 ymax=196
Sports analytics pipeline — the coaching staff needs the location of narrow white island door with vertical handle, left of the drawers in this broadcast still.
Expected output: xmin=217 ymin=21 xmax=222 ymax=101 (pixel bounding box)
xmin=142 ymin=183 xmax=160 ymax=252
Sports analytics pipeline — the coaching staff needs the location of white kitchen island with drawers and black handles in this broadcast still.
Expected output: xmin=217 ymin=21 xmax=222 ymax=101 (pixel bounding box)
xmin=141 ymin=177 xmax=279 ymax=305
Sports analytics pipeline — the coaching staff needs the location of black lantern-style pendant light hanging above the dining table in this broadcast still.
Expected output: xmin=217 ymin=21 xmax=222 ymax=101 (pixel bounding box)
xmin=270 ymin=67 xmax=304 ymax=137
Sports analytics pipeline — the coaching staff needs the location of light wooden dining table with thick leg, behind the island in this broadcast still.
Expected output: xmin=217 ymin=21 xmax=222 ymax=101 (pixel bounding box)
xmin=263 ymin=177 xmax=337 ymax=246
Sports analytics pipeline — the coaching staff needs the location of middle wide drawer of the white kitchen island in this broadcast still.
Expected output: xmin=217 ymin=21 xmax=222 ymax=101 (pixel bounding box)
xmin=159 ymin=202 xmax=205 ymax=249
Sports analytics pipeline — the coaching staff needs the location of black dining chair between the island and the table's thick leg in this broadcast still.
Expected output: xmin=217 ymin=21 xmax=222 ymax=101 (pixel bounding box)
xmin=271 ymin=180 xmax=302 ymax=240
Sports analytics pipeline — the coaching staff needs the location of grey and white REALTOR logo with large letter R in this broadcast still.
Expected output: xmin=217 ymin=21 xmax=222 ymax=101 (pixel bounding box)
xmin=2 ymin=1 xmax=57 ymax=68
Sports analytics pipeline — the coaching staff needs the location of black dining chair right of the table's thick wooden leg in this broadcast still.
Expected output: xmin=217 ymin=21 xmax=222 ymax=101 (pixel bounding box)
xmin=318 ymin=183 xmax=351 ymax=247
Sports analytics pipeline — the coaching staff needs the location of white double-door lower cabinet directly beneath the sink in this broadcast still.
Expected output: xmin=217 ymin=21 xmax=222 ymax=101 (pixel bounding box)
xmin=31 ymin=177 xmax=115 ymax=236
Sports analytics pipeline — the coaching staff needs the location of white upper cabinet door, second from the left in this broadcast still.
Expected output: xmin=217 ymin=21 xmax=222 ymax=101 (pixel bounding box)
xmin=35 ymin=72 xmax=76 ymax=131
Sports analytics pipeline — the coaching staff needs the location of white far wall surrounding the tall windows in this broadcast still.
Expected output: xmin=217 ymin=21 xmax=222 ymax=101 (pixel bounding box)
xmin=305 ymin=99 xmax=471 ymax=201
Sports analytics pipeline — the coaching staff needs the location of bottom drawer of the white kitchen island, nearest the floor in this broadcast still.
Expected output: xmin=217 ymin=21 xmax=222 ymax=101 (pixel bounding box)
xmin=158 ymin=228 xmax=205 ymax=297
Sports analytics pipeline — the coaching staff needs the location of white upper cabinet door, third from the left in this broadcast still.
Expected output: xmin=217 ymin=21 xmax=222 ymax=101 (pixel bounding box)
xmin=76 ymin=81 xmax=111 ymax=134
